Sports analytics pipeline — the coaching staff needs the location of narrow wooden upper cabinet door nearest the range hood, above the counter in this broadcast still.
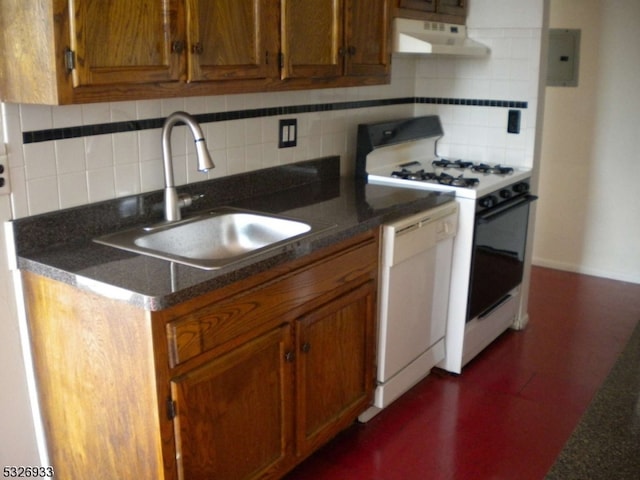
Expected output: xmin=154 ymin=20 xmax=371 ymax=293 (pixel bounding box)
xmin=346 ymin=0 xmax=390 ymax=76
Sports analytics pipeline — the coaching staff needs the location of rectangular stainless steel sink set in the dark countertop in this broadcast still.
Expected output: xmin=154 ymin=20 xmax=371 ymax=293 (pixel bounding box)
xmin=94 ymin=208 xmax=336 ymax=270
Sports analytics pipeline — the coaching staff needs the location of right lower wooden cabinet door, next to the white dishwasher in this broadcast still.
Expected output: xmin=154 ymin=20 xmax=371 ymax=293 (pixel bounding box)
xmin=296 ymin=281 xmax=375 ymax=455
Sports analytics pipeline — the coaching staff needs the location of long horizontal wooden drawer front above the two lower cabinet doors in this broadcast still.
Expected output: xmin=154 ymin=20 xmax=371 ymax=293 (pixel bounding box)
xmin=167 ymin=237 xmax=378 ymax=368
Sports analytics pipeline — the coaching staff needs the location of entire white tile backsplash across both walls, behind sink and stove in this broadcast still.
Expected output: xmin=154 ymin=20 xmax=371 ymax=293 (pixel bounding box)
xmin=4 ymin=23 xmax=540 ymax=218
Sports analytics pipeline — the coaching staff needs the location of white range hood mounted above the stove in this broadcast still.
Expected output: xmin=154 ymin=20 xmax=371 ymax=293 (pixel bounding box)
xmin=393 ymin=18 xmax=489 ymax=57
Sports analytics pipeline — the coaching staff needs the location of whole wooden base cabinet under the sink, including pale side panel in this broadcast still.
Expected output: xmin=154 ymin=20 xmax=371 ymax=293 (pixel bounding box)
xmin=23 ymin=231 xmax=378 ymax=480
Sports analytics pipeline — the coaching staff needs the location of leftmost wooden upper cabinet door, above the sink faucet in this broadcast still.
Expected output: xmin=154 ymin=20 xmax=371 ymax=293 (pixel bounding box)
xmin=70 ymin=0 xmax=184 ymax=87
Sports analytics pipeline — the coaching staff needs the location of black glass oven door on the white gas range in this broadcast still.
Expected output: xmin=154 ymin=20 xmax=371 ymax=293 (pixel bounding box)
xmin=467 ymin=195 xmax=537 ymax=322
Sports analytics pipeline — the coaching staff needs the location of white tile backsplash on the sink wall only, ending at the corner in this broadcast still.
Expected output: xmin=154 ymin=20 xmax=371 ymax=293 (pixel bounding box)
xmin=5 ymin=71 xmax=413 ymax=218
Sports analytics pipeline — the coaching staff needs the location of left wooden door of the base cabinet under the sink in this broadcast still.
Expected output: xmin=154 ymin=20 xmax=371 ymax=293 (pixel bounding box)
xmin=171 ymin=326 xmax=293 ymax=480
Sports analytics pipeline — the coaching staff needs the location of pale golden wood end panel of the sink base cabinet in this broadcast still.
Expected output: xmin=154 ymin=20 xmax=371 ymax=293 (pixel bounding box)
xmin=23 ymin=272 xmax=166 ymax=480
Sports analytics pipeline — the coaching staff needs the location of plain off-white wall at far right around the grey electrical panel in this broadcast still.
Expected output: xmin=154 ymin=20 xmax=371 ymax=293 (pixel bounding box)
xmin=533 ymin=0 xmax=640 ymax=283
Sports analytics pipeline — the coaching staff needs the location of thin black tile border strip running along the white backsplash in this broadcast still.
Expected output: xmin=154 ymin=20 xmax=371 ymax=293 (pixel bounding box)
xmin=22 ymin=97 xmax=528 ymax=144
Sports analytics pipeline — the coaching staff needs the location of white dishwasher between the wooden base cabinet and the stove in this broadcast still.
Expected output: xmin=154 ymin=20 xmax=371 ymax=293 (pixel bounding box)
xmin=359 ymin=202 xmax=456 ymax=422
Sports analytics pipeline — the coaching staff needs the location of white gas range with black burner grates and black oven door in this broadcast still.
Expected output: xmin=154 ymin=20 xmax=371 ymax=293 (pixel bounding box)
xmin=356 ymin=116 xmax=536 ymax=373
